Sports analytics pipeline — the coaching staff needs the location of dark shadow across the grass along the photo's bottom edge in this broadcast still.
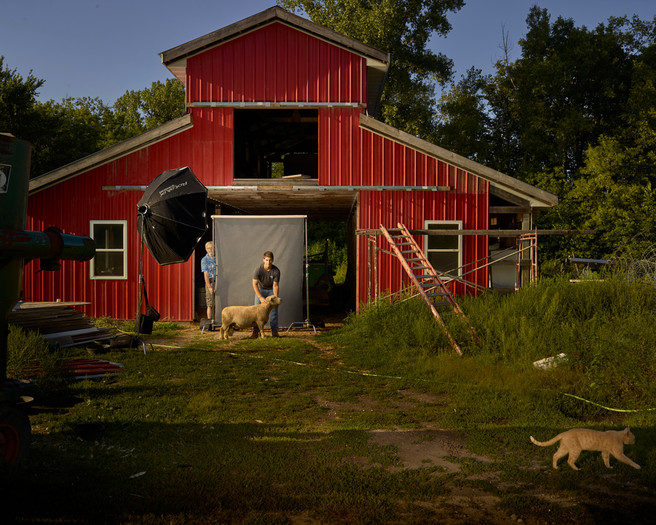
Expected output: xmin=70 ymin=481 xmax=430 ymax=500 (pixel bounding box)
xmin=0 ymin=421 xmax=656 ymax=523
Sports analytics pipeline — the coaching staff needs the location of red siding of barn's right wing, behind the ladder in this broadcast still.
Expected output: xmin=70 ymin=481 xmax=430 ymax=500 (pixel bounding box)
xmin=319 ymin=108 xmax=489 ymax=300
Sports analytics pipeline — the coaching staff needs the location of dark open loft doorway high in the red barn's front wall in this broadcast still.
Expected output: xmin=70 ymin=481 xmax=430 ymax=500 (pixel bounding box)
xmin=234 ymin=108 xmax=319 ymax=179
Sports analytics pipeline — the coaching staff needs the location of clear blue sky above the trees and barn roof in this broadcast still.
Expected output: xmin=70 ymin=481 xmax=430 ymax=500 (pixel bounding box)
xmin=0 ymin=0 xmax=656 ymax=104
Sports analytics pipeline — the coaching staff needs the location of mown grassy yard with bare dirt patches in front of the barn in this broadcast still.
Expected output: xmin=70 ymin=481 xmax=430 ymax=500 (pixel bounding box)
xmin=0 ymin=276 xmax=656 ymax=524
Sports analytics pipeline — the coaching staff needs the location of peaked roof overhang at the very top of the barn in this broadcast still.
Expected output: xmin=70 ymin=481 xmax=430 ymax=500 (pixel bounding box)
xmin=159 ymin=6 xmax=390 ymax=115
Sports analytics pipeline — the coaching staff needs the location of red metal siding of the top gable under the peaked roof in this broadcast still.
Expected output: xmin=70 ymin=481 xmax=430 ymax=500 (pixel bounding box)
xmin=187 ymin=22 xmax=367 ymax=104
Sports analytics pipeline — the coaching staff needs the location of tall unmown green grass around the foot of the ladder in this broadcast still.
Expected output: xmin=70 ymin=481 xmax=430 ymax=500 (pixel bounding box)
xmin=332 ymin=275 xmax=656 ymax=409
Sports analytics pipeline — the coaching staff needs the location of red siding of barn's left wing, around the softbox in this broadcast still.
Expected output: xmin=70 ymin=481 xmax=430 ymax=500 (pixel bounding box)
xmin=23 ymin=108 xmax=232 ymax=320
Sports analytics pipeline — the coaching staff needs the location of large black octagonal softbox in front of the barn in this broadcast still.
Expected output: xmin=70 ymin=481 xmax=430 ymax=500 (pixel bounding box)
xmin=137 ymin=167 xmax=207 ymax=266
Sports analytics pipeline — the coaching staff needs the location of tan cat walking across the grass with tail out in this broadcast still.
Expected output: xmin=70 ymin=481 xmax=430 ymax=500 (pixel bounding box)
xmin=531 ymin=427 xmax=640 ymax=470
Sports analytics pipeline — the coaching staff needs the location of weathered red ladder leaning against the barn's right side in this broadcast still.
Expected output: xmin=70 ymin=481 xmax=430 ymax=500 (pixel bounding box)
xmin=380 ymin=223 xmax=478 ymax=355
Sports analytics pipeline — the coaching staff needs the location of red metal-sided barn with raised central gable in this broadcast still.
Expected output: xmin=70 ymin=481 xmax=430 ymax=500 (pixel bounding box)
xmin=23 ymin=7 xmax=557 ymax=320
